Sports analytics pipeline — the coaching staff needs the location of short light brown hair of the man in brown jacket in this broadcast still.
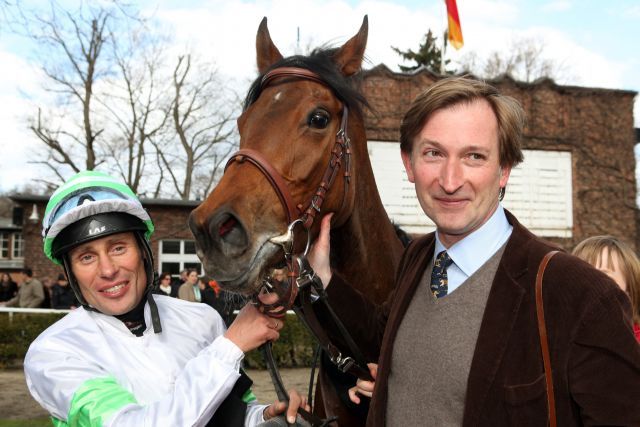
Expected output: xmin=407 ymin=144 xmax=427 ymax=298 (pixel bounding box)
xmin=400 ymin=77 xmax=525 ymax=167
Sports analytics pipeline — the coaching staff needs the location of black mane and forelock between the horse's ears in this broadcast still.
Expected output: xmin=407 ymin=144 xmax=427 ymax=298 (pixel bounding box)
xmin=244 ymin=48 xmax=369 ymax=111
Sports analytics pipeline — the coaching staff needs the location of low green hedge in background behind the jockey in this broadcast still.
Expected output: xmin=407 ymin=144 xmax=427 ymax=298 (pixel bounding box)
xmin=0 ymin=313 xmax=315 ymax=369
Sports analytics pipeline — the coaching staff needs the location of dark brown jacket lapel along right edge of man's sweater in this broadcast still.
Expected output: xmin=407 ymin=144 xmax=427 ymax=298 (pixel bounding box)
xmin=463 ymin=211 xmax=530 ymax=425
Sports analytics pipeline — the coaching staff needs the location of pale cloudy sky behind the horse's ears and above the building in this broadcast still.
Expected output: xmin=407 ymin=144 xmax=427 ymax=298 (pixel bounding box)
xmin=0 ymin=0 xmax=640 ymax=193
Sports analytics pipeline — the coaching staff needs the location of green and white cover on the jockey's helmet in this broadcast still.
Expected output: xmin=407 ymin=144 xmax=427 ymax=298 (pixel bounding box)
xmin=42 ymin=171 xmax=154 ymax=264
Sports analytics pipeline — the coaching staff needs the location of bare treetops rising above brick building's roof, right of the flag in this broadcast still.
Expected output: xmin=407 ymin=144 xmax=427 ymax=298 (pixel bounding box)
xmin=459 ymin=38 xmax=567 ymax=82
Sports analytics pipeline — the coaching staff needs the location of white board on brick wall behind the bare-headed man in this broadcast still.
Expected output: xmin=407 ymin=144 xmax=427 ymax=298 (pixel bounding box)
xmin=368 ymin=141 xmax=573 ymax=237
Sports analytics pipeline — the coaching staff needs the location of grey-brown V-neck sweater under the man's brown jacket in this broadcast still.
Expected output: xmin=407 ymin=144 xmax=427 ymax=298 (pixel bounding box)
xmin=386 ymin=245 xmax=505 ymax=426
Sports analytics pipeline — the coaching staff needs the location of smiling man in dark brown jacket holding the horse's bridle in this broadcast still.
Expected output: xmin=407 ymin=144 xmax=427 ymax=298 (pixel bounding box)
xmin=310 ymin=78 xmax=640 ymax=426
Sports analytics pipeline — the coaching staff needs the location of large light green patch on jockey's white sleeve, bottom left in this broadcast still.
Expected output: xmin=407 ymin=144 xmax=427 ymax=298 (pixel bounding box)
xmin=57 ymin=377 xmax=138 ymax=427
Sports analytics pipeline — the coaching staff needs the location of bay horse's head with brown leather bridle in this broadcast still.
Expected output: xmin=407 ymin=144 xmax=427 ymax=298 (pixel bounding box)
xmin=189 ymin=17 xmax=367 ymax=295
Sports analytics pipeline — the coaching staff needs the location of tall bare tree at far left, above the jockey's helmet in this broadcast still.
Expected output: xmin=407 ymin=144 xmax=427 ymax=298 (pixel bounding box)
xmin=23 ymin=2 xmax=113 ymax=175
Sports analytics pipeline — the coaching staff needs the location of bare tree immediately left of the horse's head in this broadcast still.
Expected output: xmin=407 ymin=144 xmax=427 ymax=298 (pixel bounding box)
xmin=155 ymin=54 xmax=240 ymax=200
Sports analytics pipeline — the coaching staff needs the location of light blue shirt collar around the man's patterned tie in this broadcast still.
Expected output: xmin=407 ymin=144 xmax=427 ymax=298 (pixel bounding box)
xmin=431 ymin=204 xmax=513 ymax=297
